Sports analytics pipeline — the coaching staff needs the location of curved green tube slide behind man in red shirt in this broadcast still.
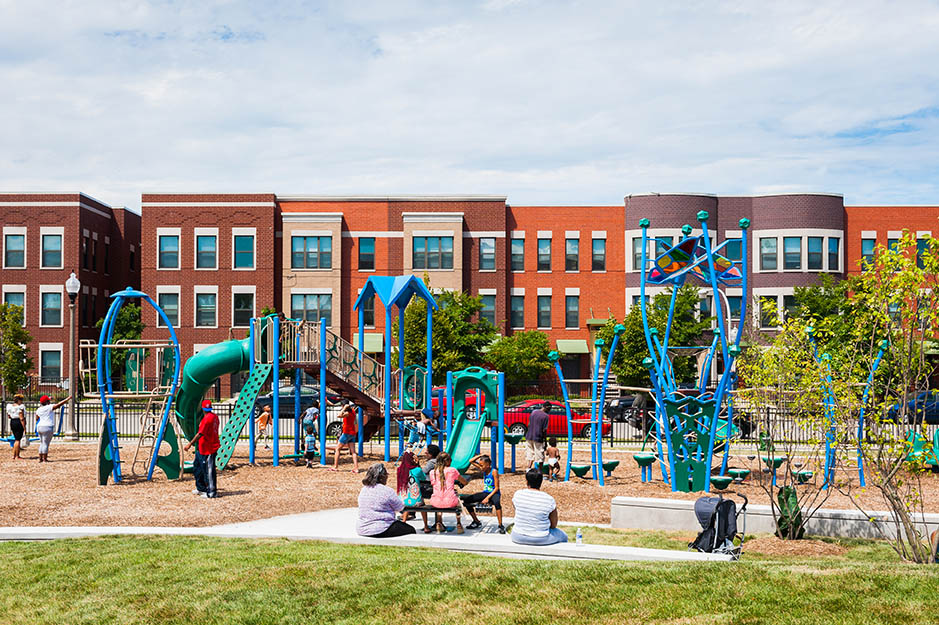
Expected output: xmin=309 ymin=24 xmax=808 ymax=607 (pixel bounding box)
xmin=176 ymin=339 xmax=251 ymax=440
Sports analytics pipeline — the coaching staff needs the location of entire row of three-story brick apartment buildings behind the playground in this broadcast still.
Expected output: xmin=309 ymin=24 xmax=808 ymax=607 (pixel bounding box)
xmin=0 ymin=193 xmax=939 ymax=394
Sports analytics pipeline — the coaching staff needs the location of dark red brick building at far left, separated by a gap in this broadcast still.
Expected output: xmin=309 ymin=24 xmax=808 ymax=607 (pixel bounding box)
xmin=0 ymin=193 xmax=140 ymax=384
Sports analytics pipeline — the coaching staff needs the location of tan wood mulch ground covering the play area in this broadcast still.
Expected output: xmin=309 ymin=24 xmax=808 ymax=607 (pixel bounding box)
xmin=0 ymin=440 xmax=939 ymax=527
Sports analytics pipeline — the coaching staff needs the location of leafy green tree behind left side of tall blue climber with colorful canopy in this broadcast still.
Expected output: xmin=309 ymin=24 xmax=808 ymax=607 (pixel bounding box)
xmin=597 ymin=284 xmax=711 ymax=387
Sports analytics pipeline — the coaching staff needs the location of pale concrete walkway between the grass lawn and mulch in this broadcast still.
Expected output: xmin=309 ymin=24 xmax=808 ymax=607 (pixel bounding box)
xmin=0 ymin=508 xmax=730 ymax=562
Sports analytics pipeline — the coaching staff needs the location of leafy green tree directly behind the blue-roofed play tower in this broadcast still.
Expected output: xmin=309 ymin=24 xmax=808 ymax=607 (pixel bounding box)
xmin=387 ymin=291 xmax=496 ymax=384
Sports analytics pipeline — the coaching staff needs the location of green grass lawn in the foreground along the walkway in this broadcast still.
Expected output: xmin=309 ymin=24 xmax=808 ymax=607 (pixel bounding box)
xmin=0 ymin=528 xmax=939 ymax=625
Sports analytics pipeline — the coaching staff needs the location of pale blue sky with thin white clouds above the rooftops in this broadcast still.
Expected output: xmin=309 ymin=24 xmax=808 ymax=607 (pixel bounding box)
xmin=0 ymin=0 xmax=939 ymax=208
